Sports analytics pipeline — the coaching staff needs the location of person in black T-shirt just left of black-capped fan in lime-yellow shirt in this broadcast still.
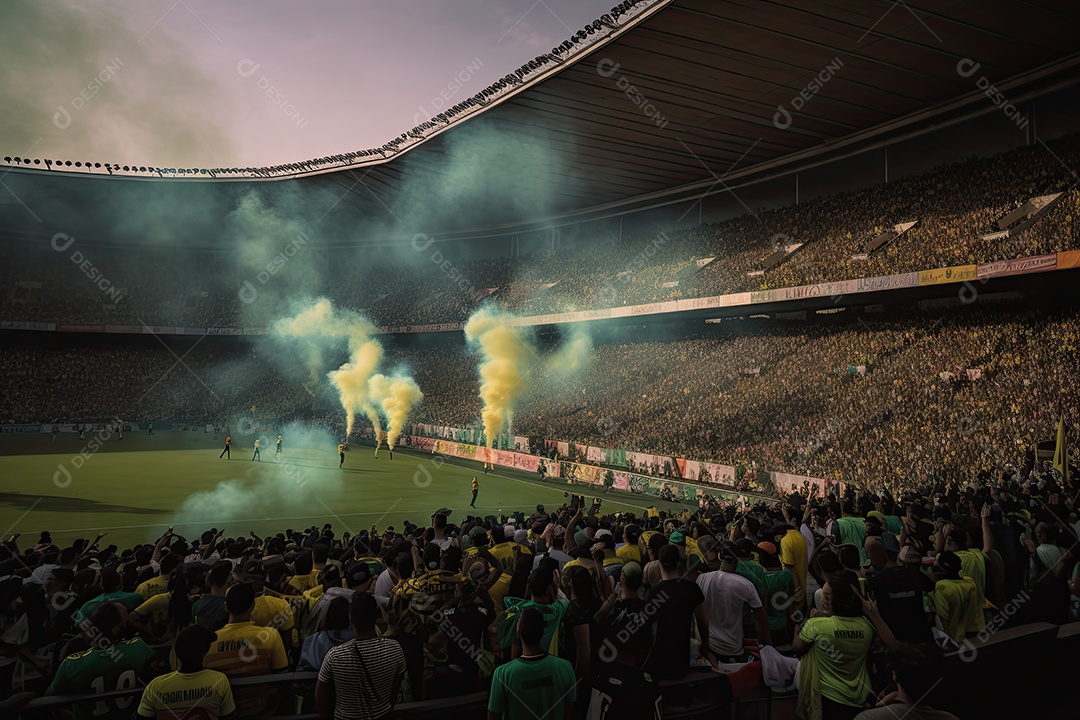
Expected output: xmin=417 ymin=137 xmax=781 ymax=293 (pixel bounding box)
xmin=867 ymin=531 xmax=934 ymax=642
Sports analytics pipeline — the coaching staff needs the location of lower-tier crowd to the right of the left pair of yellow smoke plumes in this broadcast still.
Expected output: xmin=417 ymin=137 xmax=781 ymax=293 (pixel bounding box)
xmin=401 ymin=313 xmax=1080 ymax=491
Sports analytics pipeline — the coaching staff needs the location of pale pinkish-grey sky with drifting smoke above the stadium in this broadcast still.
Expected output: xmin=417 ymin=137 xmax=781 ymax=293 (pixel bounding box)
xmin=0 ymin=0 xmax=617 ymax=167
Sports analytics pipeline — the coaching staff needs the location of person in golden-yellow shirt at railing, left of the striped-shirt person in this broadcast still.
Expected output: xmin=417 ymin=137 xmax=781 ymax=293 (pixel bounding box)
xmin=201 ymin=583 xmax=288 ymax=718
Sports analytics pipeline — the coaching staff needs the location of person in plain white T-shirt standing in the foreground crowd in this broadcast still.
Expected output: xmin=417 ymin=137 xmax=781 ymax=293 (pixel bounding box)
xmin=698 ymin=546 xmax=772 ymax=663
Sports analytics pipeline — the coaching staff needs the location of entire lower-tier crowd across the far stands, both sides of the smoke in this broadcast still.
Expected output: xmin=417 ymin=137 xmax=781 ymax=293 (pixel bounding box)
xmin=6 ymin=311 xmax=1080 ymax=498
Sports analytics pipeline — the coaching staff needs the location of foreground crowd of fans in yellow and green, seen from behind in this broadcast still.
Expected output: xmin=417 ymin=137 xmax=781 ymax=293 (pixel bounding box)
xmin=0 ymin=465 xmax=1080 ymax=720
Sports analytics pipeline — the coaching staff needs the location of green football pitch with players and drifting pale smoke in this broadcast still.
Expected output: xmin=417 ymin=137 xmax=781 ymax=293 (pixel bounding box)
xmin=0 ymin=432 xmax=678 ymax=548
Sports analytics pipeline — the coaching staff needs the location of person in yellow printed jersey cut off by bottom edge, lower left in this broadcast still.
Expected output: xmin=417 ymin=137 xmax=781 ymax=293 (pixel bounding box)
xmin=138 ymin=625 xmax=237 ymax=720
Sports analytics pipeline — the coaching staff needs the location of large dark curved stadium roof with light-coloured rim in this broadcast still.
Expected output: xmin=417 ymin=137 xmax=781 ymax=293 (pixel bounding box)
xmin=2 ymin=0 xmax=1080 ymax=240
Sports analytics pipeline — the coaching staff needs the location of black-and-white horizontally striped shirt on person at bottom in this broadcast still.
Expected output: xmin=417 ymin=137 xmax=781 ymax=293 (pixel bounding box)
xmin=319 ymin=638 xmax=405 ymax=720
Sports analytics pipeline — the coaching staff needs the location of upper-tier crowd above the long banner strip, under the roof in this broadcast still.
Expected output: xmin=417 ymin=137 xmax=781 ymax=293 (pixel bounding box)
xmin=0 ymin=137 xmax=1080 ymax=327
